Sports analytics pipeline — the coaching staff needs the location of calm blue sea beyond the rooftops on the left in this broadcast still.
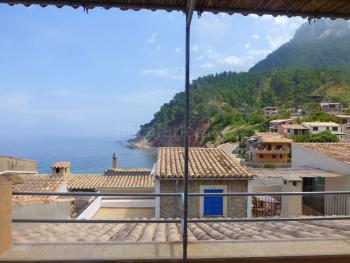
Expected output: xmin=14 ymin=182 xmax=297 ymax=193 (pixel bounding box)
xmin=0 ymin=137 xmax=156 ymax=173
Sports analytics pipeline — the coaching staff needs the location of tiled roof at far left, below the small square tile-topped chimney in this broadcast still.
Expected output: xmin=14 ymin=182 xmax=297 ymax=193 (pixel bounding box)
xmin=12 ymin=174 xmax=65 ymax=204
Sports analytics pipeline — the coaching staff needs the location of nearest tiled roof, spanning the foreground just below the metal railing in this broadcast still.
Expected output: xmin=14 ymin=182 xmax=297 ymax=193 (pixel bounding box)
xmin=13 ymin=220 xmax=350 ymax=244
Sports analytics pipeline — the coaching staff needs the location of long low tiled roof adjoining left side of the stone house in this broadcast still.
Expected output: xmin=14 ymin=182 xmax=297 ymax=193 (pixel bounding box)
xmin=67 ymin=172 xmax=154 ymax=191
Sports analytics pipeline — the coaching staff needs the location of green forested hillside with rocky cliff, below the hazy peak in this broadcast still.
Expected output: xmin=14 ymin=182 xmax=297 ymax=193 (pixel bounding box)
xmin=138 ymin=69 xmax=350 ymax=146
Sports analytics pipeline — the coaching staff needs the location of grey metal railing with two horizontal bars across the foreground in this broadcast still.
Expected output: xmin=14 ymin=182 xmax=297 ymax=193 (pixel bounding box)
xmin=12 ymin=191 xmax=350 ymax=261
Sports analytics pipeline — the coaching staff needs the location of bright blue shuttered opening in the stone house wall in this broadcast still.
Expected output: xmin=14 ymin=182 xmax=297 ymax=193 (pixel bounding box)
xmin=203 ymin=189 xmax=224 ymax=216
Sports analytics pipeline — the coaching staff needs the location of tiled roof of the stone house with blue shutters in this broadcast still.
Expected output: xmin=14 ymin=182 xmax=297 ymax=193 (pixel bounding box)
xmin=156 ymin=147 xmax=252 ymax=178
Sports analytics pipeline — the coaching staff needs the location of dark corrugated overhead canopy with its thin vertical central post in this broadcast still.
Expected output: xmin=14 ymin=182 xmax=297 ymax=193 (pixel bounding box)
xmin=0 ymin=0 xmax=350 ymax=262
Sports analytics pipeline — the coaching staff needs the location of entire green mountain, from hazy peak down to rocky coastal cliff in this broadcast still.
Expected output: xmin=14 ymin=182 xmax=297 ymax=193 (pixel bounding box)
xmin=134 ymin=20 xmax=350 ymax=147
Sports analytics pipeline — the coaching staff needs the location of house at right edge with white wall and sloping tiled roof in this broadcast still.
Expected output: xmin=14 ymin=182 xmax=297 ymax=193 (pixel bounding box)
xmin=292 ymin=143 xmax=350 ymax=215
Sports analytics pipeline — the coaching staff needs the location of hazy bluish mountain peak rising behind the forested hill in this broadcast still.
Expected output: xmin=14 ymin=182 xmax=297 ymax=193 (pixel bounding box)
xmin=250 ymin=19 xmax=350 ymax=71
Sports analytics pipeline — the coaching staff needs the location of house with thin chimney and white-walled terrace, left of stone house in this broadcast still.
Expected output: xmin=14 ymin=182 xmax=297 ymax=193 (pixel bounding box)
xmin=67 ymin=154 xmax=155 ymax=219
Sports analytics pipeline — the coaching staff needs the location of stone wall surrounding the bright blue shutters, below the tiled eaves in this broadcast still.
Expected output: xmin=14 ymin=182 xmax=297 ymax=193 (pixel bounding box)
xmin=160 ymin=179 xmax=248 ymax=218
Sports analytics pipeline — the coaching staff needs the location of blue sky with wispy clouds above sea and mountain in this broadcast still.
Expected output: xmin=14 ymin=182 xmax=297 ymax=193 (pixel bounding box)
xmin=0 ymin=5 xmax=305 ymax=138
